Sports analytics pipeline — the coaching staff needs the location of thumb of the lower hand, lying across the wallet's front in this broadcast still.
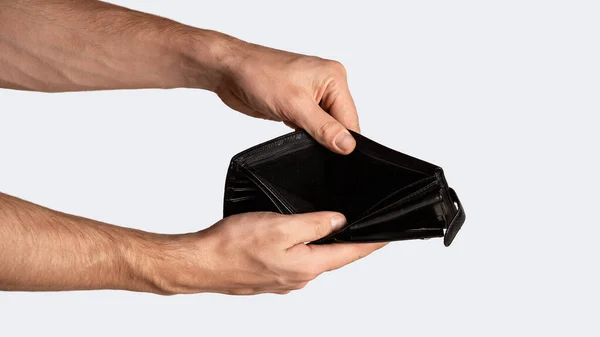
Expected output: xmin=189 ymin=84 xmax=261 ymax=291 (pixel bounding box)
xmin=286 ymin=212 xmax=346 ymax=245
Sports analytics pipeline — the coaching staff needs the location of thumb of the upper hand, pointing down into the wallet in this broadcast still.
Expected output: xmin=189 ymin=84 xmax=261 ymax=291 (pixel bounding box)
xmin=293 ymin=100 xmax=356 ymax=154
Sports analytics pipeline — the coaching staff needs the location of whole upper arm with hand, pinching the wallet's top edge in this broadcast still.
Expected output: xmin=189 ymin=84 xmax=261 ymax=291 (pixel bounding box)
xmin=0 ymin=0 xmax=360 ymax=154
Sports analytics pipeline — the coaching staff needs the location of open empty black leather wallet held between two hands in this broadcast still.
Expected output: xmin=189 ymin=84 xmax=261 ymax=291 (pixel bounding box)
xmin=223 ymin=131 xmax=465 ymax=246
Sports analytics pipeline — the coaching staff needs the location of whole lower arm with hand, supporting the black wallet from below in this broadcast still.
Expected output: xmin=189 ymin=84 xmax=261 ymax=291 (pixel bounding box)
xmin=0 ymin=193 xmax=384 ymax=295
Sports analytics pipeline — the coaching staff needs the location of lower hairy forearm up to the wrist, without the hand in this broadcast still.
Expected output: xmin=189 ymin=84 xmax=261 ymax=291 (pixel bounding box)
xmin=0 ymin=193 xmax=172 ymax=293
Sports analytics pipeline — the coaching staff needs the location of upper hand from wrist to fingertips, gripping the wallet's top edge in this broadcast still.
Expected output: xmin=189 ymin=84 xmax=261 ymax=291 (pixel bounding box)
xmin=214 ymin=40 xmax=360 ymax=154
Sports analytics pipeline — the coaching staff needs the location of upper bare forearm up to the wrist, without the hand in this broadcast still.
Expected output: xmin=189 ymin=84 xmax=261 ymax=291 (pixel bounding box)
xmin=0 ymin=0 xmax=234 ymax=92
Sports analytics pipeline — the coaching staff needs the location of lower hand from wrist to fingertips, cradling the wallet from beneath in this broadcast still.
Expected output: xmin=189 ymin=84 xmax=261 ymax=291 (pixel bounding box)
xmin=155 ymin=212 xmax=385 ymax=295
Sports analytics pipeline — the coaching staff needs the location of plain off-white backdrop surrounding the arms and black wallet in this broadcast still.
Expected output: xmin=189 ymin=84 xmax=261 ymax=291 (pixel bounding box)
xmin=0 ymin=0 xmax=600 ymax=336
